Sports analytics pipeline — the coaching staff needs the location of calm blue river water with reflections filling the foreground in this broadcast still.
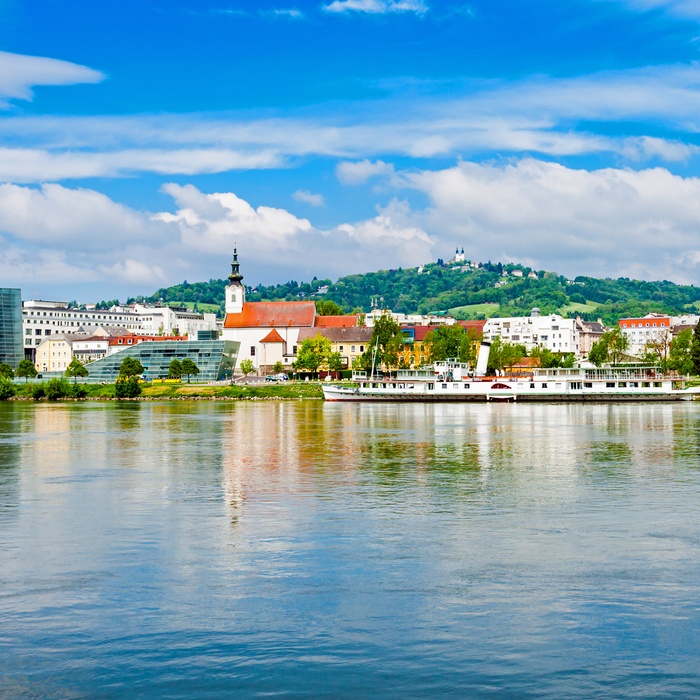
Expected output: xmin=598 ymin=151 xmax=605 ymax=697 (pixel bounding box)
xmin=0 ymin=401 xmax=700 ymax=698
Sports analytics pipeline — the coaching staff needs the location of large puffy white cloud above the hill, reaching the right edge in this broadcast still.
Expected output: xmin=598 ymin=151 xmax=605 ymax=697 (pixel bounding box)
xmin=402 ymin=159 xmax=700 ymax=283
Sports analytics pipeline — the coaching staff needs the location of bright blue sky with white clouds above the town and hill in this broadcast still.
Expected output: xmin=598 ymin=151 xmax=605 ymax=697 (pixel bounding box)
xmin=0 ymin=0 xmax=700 ymax=302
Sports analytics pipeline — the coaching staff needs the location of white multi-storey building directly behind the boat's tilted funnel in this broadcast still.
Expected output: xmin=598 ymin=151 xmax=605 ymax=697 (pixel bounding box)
xmin=484 ymin=308 xmax=581 ymax=357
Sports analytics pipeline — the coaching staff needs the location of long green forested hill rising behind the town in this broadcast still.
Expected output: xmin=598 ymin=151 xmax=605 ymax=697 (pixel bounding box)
xmin=138 ymin=262 xmax=700 ymax=323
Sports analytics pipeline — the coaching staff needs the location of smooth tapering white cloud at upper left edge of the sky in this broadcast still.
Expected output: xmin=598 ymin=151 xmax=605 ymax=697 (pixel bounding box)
xmin=0 ymin=51 xmax=105 ymax=106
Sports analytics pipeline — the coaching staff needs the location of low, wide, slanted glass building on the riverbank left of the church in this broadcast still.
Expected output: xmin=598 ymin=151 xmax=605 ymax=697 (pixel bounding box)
xmin=84 ymin=340 xmax=240 ymax=384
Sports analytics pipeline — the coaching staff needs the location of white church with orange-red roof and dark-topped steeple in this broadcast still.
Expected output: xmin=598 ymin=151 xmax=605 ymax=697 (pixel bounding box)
xmin=222 ymin=249 xmax=358 ymax=374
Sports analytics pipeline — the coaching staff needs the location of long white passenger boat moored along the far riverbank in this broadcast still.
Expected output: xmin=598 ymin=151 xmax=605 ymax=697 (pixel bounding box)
xmin=323 ymin=361 xmax=700 ymax=401
